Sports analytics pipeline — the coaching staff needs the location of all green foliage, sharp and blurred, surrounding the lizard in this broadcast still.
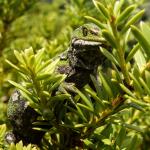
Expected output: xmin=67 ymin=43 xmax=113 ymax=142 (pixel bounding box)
xmin=0 ymin=0 xmax=150 ymax=150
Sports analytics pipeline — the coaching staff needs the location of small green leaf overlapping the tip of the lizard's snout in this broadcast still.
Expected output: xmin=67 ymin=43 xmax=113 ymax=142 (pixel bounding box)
xmin=102 ymin=30 xmax=118 ymax=49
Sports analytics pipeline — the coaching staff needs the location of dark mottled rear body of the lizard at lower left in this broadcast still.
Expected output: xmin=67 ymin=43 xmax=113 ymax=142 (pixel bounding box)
xmin=6 ymin=90 xmax=44 ymax=144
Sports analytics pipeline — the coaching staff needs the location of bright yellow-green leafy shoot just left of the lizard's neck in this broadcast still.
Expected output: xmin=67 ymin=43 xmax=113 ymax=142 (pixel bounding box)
xmin=6 ymin=48 xmax=67 ymax=117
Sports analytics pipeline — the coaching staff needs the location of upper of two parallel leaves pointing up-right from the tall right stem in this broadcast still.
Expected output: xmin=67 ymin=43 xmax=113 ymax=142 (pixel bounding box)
xmin=116 ymin=5 xmax=135 ymax=24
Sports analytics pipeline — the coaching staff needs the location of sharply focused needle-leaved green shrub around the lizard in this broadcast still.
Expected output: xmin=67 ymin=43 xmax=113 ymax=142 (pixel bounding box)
xmin=0 ymin=0 xmax=150 ymax=150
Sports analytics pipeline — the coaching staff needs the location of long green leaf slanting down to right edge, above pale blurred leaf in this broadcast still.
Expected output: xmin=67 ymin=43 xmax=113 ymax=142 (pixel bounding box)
xmin=131 ymin=25 xmax=150 ymax=57
